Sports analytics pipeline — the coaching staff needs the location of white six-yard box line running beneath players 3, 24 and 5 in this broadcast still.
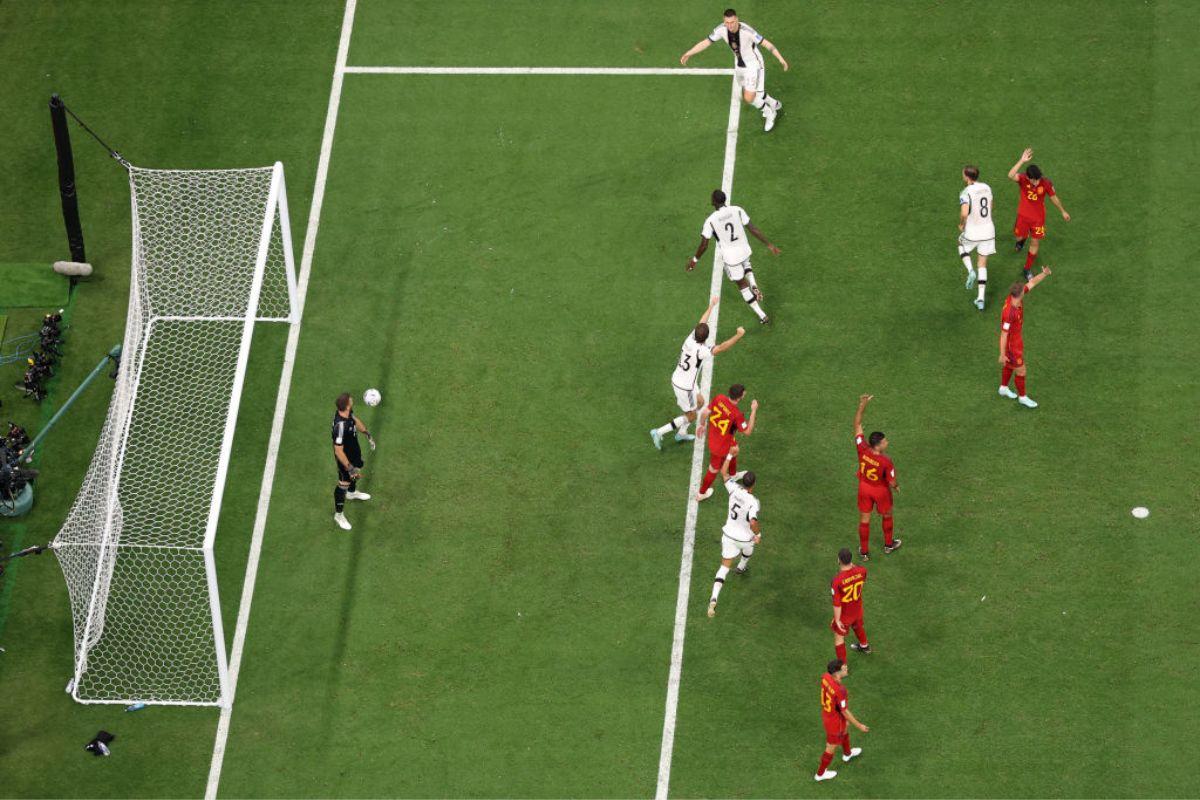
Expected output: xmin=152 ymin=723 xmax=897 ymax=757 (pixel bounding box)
xmin=654 ymin=80 xmax=742 ymax=800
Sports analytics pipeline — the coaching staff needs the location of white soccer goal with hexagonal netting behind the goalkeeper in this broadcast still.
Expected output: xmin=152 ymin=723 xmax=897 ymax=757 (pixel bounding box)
xmin=53 ymin=163 xmax=298 ymax=705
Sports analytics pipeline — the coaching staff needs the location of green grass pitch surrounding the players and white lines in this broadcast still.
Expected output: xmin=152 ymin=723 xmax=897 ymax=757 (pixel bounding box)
xmin=0 ymin=0 xmax=1200 ymax=798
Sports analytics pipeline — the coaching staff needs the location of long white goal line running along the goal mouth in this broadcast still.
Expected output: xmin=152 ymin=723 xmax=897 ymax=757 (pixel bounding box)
xmin=204 ymin=0 xmax=356 ymax=800
